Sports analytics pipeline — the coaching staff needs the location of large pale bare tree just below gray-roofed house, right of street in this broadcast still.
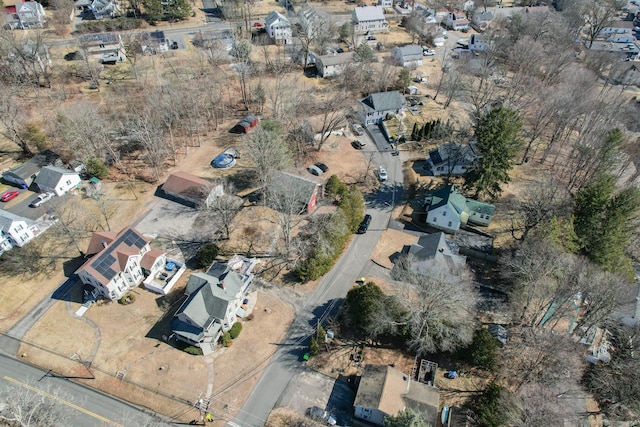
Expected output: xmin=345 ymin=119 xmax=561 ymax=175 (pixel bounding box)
xmin=388 ymin=262 xmax=478 ymax=354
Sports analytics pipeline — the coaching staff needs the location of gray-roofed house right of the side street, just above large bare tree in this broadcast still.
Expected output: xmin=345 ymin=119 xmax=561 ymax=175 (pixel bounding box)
xmin=402 ymin=232 xmax=466 ymax=275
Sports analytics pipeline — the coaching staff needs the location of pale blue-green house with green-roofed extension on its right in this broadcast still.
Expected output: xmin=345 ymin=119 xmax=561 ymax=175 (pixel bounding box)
xmin=425 ymin=185 xmax=496 ymax=234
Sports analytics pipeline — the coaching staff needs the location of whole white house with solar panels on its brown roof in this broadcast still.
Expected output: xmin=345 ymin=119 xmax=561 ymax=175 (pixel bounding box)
xmin=76 ymin=227 xmax=175 ymax=300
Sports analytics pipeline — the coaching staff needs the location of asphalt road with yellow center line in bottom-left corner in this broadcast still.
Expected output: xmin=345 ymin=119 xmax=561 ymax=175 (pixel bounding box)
xmin=0 ymin=355 xmax=169 ymax=427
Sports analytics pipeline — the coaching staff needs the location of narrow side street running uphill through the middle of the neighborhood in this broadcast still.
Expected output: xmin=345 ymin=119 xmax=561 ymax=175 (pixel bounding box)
xmin=227 ymin=135 xmax=402 ymax=427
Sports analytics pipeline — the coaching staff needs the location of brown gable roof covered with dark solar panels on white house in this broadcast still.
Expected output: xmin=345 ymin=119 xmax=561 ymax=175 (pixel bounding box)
xmin=80 ymin=227 xmax=149 ymax=286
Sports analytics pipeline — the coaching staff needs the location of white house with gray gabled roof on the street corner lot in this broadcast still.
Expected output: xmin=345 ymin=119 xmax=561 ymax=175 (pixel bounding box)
xmin=171 ymin=255 xmax=258 ymax=354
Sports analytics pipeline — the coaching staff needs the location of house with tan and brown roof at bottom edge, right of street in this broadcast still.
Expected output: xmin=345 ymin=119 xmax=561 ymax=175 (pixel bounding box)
xmin=353 ymin=365 xmax=440 ymax=426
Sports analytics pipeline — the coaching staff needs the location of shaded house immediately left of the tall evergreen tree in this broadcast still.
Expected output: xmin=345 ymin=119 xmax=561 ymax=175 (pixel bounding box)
xmin=425 ymin=142 xmax=480 ymax=176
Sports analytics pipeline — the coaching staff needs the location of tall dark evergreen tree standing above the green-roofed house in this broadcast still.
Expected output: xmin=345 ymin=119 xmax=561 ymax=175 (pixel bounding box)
xmin=465 ymin=107 xmax=522 ymax=201
